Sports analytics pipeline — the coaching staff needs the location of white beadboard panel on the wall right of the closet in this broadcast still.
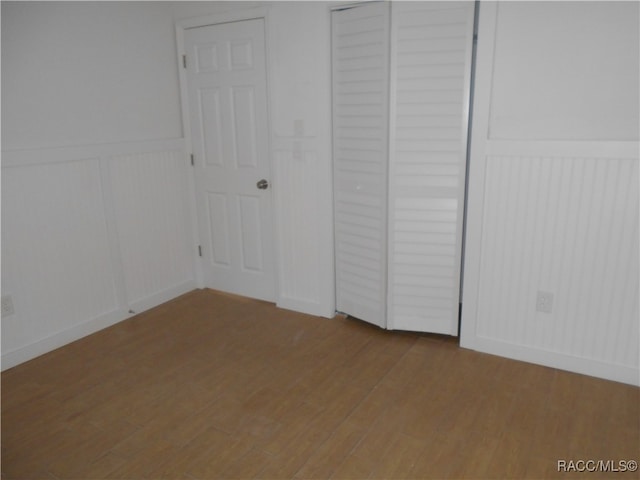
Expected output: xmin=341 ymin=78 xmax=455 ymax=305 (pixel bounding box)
xmin=477 ymin=156 xmax=640 ymax=368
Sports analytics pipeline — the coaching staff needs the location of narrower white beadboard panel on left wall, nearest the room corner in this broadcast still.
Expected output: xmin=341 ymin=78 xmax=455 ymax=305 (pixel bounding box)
xmin=109 ymin=152 xmax=196 ymax=310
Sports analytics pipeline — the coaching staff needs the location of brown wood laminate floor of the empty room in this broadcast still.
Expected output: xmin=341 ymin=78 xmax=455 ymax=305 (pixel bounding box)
xmin=2 ymin=290 xmax=640 ymax=480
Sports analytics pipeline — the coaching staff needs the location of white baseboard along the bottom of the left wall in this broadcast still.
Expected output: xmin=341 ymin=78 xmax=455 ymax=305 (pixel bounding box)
xmin=0 ymin=280 xmax=196 ymax=371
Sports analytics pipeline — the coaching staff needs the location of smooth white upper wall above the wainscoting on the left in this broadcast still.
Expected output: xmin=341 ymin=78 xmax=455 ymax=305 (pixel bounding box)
xmin=2 ymin=2 xmax=182 ymax=150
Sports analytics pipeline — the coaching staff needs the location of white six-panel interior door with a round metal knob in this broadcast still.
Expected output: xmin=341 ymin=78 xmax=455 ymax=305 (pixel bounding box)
xmin=185 ymin=19 xmax=276 ymax=301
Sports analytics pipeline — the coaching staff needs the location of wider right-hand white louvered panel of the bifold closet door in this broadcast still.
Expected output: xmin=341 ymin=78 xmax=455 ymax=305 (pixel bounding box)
xmin=388 ymin=2 xmax=474 ymax=335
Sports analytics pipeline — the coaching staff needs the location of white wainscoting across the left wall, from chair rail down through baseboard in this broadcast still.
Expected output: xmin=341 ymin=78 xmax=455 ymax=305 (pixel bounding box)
xmin=2 ymin=139 xmax=195 ymax=369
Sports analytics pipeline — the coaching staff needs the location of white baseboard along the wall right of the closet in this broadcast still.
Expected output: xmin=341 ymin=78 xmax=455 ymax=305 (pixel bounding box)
xmin=460 ymin=335 xmax=640 ymax=386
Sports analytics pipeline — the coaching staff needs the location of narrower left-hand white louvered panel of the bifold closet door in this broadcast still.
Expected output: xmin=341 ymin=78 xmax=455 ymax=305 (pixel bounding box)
xmin=332 ymin=3 xmax=389 ymax=327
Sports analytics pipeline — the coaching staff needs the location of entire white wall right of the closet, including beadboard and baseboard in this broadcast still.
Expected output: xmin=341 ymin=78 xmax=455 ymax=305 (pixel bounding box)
xmin=461 ymin=2 xmax=640 ymax=384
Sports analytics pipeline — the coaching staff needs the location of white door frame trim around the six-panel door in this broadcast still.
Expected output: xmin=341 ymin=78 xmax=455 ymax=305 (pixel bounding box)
xmin=175 ymin=7 xmax=280 ymax=303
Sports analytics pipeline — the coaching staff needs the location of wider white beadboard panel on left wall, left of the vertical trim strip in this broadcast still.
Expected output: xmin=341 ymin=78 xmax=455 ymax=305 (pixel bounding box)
xmin=2 ymin=158 xmax=120 ymax=368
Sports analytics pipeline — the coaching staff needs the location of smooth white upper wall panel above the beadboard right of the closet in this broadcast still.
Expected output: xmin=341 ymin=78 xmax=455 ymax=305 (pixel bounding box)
xmin=489 ymin=2 xmax=640 ymax=140
